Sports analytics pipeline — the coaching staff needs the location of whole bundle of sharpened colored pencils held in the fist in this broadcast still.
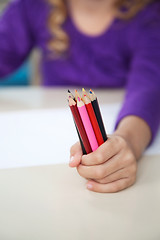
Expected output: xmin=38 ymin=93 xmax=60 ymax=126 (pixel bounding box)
xmin=68 ymin=88 xmax=107 ymax=154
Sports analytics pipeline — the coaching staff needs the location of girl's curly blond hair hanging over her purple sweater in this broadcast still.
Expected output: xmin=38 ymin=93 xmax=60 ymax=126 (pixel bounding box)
xmin=48 ymin=0 xmax=154 ymax=55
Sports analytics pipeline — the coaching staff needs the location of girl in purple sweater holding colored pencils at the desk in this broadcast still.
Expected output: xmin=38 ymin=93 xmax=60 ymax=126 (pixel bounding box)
xmin=0 ymin=0 xmax=160 ymax=192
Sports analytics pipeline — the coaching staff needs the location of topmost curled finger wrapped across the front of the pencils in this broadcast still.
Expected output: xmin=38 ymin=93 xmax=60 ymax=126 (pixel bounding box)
xmin=82 ymin=136 xmax=126 ymax=166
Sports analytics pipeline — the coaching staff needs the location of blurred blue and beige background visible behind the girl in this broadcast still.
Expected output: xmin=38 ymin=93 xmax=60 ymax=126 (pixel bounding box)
xmin=0 ymin=0 xmax=40 ymax=87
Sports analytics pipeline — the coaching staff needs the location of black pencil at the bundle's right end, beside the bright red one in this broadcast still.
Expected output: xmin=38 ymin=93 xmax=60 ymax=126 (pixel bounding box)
xmin=89 ymin=89 xmax=107 ymax=142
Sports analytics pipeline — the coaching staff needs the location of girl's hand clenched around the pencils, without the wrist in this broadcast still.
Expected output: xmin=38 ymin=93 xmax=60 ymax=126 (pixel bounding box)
xmin=70 ymin=135 xmax=137 ymax=193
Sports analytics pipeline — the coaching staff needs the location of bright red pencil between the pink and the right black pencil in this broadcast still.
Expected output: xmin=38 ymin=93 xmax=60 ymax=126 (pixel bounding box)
xmin=83 ymin=94 xmax=104 ymax=146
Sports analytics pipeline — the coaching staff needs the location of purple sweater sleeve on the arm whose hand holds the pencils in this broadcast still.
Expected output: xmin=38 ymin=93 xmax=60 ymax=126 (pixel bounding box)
xmin=116 ymin=7 xmax=160 ymax=142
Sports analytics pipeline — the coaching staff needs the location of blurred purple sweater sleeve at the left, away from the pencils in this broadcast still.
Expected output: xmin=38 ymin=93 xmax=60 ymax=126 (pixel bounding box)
xmin=0 ymin=0 xmax=34 ymax=77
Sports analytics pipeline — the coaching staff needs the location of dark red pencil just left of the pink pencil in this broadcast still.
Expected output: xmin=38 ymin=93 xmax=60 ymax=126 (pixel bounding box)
xmin=69 ymin=97 xmax=92 ymax=154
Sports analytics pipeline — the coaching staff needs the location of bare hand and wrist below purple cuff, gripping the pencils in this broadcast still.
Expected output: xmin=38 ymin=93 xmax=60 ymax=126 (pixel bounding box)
xmin=70 ymin=116 xmax=151 ymax=192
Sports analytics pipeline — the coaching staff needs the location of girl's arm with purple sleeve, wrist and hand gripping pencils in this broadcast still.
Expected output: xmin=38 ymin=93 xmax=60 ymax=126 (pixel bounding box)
xmin=70 ymin=7 xmax=160 ymax=192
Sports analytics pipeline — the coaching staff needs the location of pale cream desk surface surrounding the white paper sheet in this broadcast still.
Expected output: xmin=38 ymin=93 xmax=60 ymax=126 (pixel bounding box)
xmin=0 ymin=88 xmax=160 ymax=240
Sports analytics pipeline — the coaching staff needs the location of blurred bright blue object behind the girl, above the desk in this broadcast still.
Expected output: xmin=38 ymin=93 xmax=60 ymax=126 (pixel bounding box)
xmin=0 ymin=61 xmax=31 ymax=87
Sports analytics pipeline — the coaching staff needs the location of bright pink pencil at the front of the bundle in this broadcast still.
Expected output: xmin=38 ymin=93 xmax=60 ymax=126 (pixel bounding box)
xmin=77 ymin=97 xmax=98 ymax=151
